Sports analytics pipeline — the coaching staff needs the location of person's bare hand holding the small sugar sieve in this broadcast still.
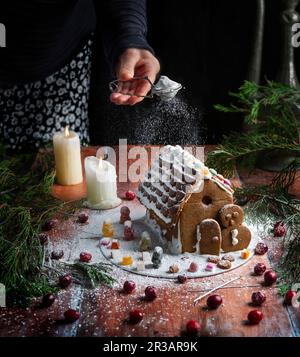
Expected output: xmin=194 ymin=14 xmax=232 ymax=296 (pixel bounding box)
xmin=110 ymin=48 xmax=160 ymax=105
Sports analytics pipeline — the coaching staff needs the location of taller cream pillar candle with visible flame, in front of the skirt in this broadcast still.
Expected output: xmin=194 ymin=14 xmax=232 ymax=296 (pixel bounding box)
xmin=53 ymin=126 xmax=83 ymax=185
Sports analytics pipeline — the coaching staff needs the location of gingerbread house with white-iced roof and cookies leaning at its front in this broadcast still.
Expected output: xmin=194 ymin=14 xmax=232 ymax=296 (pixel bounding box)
xmin=137 ymin=146 xmax=251 ymax=255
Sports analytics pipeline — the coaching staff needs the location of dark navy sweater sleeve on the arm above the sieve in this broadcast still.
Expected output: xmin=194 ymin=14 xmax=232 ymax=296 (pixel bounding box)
xmin=97 ymin=0 xmax=153 ymax=73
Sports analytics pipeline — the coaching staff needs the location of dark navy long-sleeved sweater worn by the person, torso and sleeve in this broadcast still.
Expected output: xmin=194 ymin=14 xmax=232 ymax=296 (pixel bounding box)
xmin=0 ymin=0 xmax=152 ymax=86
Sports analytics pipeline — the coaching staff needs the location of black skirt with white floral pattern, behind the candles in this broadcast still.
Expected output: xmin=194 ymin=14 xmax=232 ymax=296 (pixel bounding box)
xmin=0 ymin=34 xmax=92 ymax=150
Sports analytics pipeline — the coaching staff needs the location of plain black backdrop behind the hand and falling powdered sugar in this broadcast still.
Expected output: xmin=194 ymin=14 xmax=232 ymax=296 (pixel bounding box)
xmin=90 ymin=0 xmax=300 ymax=145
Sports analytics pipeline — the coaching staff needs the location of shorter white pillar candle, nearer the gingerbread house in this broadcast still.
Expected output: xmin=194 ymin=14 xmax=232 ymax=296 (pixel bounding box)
xmin=84 ymin=156 xmax=121 ymax=209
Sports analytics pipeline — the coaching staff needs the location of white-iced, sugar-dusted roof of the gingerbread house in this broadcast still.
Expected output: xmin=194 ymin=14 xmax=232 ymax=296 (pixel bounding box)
xmin=137 ymin=145 xmax=233 ymax=226
